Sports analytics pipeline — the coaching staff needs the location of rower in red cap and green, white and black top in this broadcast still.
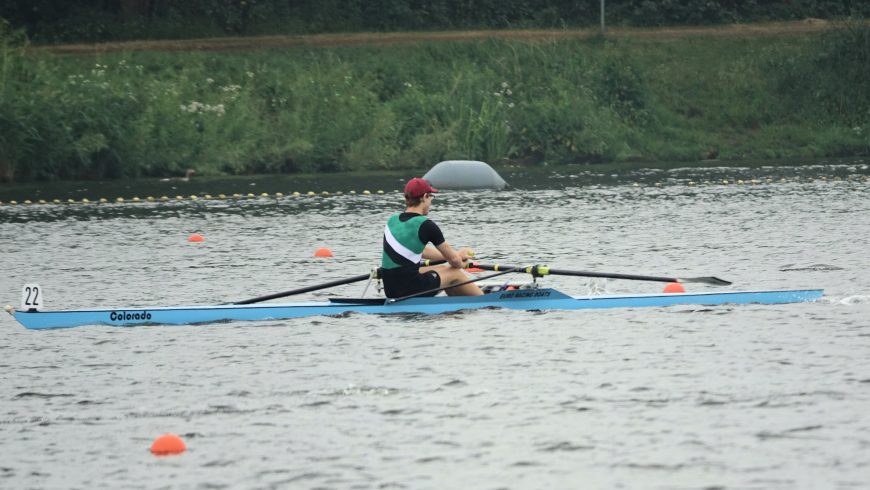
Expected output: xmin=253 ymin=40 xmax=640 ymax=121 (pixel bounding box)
xmin=381 ymin=178 xmax=483 ymax=298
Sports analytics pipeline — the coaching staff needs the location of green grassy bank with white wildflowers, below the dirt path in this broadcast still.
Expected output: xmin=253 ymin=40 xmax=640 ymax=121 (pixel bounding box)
xmin=0 ymin=24 xmax=870 ymax=181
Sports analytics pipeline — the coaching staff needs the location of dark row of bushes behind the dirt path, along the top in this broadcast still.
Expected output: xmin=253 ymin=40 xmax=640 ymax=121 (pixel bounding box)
xmin=0 ymin=0 xmax=870 ymax=43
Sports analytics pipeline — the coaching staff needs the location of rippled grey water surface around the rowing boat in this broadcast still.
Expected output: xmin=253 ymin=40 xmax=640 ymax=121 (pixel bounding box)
xmin=0 ymin=160 xmax=870 ymax=489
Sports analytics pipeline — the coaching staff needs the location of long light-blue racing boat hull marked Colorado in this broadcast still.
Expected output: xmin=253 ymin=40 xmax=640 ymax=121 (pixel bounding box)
xmin=13 ymin=289 xmax=823 ymax=329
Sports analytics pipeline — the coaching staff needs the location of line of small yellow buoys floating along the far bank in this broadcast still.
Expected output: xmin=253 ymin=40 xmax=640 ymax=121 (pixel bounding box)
xmin=0 ymin=174 xmax=870 ymax=206
